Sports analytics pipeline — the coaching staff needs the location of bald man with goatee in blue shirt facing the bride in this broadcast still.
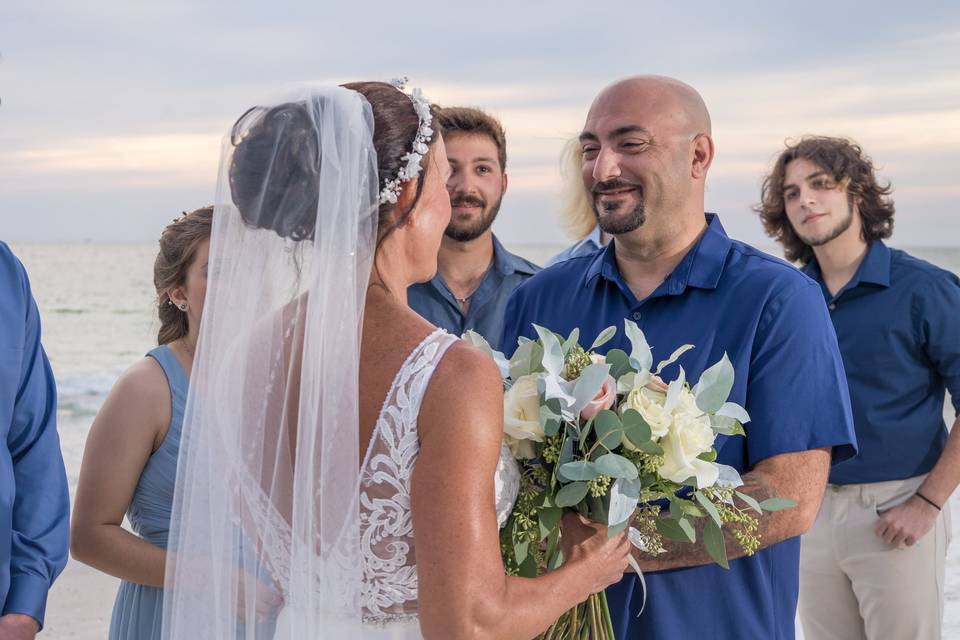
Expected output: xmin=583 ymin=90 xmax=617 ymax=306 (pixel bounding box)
xmin=500 ymin=76 xmax=856 ymax=640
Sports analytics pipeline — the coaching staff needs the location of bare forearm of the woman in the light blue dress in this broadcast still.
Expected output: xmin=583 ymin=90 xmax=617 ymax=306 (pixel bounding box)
xmin=70 ymin=524 xmax=167 ymax=587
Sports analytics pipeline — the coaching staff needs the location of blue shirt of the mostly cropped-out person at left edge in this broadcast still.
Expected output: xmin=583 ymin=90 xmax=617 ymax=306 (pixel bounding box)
xmin=0 ymin=242 xmax=70 ymax=625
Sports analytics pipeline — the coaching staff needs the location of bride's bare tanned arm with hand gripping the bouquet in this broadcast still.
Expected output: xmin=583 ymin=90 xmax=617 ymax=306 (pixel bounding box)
xmin=412 ymin=343 xmax=629 ymax=640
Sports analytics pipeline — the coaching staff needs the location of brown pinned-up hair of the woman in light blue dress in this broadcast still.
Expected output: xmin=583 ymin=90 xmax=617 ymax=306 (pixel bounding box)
xmin=153 ymin=207 xmax=213 ymax=344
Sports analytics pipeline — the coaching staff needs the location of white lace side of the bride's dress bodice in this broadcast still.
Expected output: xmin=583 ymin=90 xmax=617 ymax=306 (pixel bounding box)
xmin=360 ymin=329 xmax=520 ymax=623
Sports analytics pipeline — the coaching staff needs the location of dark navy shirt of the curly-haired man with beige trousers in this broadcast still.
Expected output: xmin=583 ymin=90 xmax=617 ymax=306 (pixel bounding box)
xmin=804 ymin=240 xmax=960 ymax=484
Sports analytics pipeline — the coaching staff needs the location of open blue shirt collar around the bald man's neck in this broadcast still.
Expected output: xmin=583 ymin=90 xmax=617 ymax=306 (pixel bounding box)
xmin=584 ymin=213 xmax=732 ymax=295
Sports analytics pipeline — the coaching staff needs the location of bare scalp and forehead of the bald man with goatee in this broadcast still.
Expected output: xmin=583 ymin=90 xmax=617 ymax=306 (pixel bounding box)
xmin=590 ymin=75 xmax=711 ymax=136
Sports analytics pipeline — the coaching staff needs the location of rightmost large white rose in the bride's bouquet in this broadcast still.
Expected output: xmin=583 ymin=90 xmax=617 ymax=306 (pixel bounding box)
xmin=657 ymin=408 xmax=719 ymax=489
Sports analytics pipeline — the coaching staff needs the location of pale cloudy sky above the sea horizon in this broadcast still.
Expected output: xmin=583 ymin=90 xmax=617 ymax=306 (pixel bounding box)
xmin=0 ymin=0 xmax=960 ymax=245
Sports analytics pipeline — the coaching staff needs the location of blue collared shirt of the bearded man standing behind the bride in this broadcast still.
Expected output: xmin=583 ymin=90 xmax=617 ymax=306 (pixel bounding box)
xmin=407 ymin=236 xmax=540 ymax=344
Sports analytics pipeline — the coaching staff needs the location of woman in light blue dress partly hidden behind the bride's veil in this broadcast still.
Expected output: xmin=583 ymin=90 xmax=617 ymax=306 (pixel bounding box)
xmin=70 ymin=208 xmax=221 ymax=640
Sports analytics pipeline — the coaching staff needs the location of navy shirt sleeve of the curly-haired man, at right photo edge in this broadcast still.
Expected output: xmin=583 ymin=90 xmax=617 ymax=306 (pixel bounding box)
xmin=918 ymin=274 xmax=960 ymax=413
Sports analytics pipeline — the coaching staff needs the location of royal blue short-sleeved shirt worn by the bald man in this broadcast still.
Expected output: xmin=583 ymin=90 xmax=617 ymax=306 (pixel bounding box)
xmin=500 ymin=214 xmax=855 ymax=640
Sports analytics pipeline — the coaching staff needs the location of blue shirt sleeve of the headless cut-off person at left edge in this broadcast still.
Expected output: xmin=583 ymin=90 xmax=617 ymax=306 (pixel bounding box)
xmin=2 ymin=256 xmax=70 ymax=626
